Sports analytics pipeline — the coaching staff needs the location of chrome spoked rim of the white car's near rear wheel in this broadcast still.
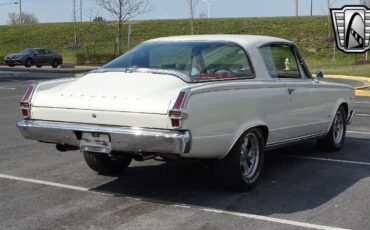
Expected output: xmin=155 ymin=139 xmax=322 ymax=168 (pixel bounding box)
xmin=240 ymin=132 xmax=260 ymax=179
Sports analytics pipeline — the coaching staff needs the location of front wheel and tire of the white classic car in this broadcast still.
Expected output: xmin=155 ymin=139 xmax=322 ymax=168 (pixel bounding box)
xmin=317 ymin=106 xmax=347 ymax=152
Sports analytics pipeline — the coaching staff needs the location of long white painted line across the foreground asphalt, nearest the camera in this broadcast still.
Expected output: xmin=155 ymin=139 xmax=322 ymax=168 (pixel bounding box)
xmin=0 ymin=174 xmax=344 ymax=230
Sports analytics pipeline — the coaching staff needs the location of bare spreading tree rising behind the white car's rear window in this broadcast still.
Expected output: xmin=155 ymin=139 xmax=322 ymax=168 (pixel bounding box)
xmin=96 ymin=0 xmax=151 ymax=55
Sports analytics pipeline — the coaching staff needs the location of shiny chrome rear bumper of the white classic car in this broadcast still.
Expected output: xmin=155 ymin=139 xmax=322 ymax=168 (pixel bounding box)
xmin=17 ymin=120 xmax=191 ymax=154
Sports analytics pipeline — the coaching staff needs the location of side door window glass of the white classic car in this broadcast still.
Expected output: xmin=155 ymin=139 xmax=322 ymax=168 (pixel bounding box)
xmin=261 ymin=45 xmax=302 ymax=78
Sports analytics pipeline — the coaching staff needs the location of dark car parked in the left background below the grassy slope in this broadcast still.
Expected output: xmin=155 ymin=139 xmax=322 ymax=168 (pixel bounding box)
xmin=4 ymin=48 xmax=63 ymax=68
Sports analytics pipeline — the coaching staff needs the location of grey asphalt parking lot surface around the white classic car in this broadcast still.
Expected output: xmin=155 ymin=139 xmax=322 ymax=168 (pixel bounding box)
xmin=0 ymin=72 xmax=370 ymax=229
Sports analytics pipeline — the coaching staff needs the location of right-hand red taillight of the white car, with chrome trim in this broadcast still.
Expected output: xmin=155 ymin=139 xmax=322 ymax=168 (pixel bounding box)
xmin=168 ymin=90 xmax=189 ymax=128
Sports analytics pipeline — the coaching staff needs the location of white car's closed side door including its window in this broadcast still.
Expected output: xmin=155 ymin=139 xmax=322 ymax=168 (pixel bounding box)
xmin=271 ymin=44 xmax=327 ymax=139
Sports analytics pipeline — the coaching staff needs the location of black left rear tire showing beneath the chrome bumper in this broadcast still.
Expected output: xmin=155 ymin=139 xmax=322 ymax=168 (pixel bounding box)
xmin=83 ymin=152 xmax=132 ymax=175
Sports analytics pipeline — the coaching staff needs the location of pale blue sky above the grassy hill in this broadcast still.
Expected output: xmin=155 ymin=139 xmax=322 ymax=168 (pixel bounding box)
xmin=0 ymin=0 xmax=359 ymax=25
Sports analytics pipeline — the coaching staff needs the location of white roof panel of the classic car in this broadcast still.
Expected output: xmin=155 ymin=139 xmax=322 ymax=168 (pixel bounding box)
xmin=147 ymin=34 xmax=292 ymax=48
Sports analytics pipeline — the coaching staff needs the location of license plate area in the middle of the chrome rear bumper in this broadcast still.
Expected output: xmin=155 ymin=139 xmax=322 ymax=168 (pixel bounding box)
xmin=80 ymin=133 xmax=112 ymax=153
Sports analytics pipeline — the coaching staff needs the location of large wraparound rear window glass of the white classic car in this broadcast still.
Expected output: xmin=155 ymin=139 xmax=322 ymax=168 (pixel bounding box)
xmin=103 ymin=42 xmax=254 ymax=81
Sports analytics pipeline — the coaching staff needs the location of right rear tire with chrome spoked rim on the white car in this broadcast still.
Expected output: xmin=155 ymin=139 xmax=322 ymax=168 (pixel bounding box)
xmin=215 ymin=128 xmax=265 ymax=191
